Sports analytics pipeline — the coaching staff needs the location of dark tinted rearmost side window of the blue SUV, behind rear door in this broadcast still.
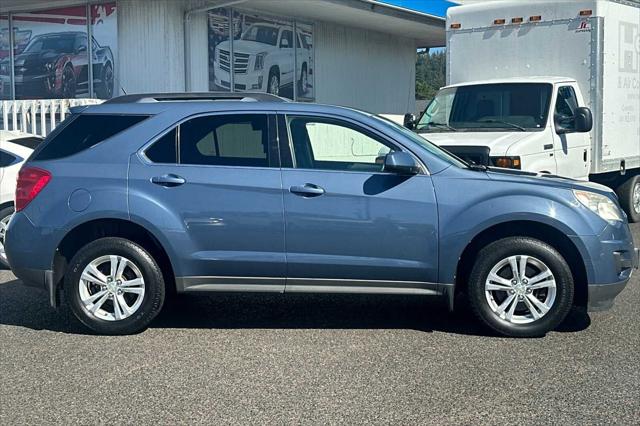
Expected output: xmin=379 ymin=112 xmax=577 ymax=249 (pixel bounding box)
xmin=34 ymin=114 xmax=147 ymax=160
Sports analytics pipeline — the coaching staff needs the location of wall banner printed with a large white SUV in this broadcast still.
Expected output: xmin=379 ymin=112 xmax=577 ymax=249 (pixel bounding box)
xmin=208 ymin=8 xmax=315 ymax=101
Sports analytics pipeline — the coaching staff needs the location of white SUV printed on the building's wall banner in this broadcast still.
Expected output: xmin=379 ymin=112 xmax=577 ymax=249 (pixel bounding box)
xmin=214 ymin=23 xmax=313 ymax=95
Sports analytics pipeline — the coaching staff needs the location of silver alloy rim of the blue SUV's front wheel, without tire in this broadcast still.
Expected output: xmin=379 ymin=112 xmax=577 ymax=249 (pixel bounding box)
xmin=485 ymin=255 xmax=556 ymax=324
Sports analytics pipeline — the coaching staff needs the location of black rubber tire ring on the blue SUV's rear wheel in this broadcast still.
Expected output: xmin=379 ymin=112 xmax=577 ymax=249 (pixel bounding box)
xmin=64 ymin=237 xmax=165 ymax=335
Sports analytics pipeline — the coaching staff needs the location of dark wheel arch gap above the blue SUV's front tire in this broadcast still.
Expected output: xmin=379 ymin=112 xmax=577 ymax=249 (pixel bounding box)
xmin=455 ymin=220 xmax=588 ymax=307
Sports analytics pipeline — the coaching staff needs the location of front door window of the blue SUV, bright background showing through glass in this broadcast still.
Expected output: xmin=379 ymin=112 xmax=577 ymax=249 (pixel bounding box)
xmin=288 ymin=117 xmax=392 ymax=172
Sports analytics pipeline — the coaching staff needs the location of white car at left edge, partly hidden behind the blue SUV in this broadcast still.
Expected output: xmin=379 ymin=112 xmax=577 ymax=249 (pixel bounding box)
xmin=0 ymin=130 xmax=42 ymax=266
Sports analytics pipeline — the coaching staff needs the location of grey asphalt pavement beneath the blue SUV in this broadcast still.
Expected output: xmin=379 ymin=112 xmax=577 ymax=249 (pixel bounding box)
xmin=0 ymin=225 xmax=640 ymax=425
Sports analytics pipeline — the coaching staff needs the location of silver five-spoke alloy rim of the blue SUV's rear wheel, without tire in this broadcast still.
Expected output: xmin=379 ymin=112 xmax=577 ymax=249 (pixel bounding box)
xmin=78 ymin=255 xmax=145 ymax=321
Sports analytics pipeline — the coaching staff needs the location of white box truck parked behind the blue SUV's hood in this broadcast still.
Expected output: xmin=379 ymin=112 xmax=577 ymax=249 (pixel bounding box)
xmin=405 ymin=0 xmax=640 ymax=222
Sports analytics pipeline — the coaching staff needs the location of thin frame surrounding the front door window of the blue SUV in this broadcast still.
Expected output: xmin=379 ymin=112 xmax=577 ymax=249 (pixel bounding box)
xmin=278 ymin=111 xmax=430 ymax=176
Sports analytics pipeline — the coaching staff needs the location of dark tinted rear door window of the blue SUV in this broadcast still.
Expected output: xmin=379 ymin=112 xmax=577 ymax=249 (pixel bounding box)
xmin=180 ymin=114 xmax=273 ymax=167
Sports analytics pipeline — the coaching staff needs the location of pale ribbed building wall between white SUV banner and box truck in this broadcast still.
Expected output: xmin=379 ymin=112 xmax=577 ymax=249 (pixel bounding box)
xmin=314 ymin=22 xmax=416 ymax=114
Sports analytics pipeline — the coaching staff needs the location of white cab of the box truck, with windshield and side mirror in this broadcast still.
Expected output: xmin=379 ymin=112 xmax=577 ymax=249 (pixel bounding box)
xmin=415 ymin=77 xmax=592 ymax=180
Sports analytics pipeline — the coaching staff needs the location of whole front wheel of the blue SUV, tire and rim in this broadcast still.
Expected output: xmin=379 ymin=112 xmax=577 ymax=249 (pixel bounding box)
xmin=468 ymin=237 xmax=573 ymax=337
